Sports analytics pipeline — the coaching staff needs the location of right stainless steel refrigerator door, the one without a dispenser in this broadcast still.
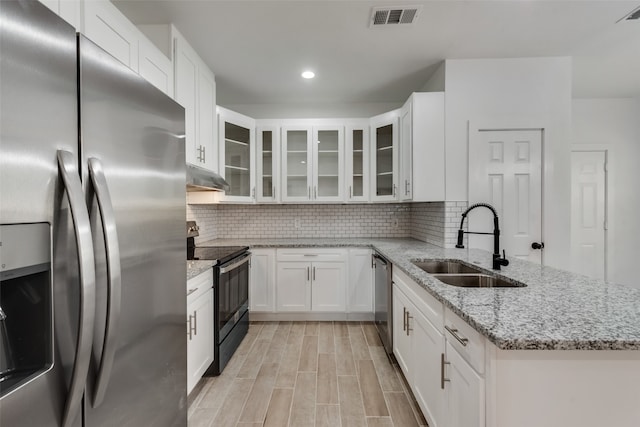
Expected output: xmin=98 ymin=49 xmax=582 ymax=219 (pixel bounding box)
xmin=79 ymin=36 xmax=186 ymax=427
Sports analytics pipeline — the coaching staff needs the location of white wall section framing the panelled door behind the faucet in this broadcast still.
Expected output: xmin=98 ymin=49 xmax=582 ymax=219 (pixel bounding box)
xmin=445 ymin=57 xmax=571 ymax=268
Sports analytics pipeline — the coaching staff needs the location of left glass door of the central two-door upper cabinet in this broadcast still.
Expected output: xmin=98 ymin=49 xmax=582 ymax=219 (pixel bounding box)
xmin=282 ymin=127 xmax=312 ymax=201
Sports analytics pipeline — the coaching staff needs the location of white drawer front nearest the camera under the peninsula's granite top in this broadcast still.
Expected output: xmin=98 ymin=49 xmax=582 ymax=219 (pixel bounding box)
xmin=444 ymin=308 xmax=485 ymax=374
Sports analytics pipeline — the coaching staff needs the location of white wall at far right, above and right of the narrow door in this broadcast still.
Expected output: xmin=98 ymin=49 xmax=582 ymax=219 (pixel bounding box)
xmin=573 ymin=98 xmax=640 ymax=288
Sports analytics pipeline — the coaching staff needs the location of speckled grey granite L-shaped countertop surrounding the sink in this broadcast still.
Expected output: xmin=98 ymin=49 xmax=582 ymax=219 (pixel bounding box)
xmin=195 ymin=238 xmax=640 ymax=350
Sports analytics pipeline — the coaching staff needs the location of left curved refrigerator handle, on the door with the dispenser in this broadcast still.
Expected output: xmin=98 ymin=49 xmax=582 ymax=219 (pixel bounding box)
xmin=57 ymin=150 xmax=96 ymax=427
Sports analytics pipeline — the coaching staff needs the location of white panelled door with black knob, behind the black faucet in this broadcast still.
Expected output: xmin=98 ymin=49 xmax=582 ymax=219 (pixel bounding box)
xmin=468 ymin=130 xmax=542 ymax=264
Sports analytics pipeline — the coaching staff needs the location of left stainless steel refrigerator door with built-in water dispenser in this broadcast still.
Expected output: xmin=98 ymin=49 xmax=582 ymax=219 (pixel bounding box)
xmin=0 ymin=1 xmax=84 ymax=427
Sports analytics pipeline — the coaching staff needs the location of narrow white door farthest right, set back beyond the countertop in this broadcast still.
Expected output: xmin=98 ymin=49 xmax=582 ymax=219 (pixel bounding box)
xmin=571 ymin=151 xmax=606 ymax=280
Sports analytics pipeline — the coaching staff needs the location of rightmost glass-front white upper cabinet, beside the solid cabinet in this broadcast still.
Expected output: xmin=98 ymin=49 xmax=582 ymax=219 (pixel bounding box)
xmin=371 ymin=110 xmax=400 ymax=202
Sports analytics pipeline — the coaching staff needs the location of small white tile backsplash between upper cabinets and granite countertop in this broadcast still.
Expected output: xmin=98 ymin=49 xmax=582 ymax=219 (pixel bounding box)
xmin=187 ymin=202 xmax=466 ymax=247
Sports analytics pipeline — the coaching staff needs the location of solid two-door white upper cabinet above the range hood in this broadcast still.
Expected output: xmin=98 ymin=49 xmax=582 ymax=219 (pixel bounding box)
xmin=173 ymin=29 xmax=218 ymax=172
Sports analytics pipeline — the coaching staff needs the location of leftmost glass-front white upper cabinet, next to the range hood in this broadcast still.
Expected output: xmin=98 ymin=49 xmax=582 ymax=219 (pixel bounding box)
xmin=218 ymin=107 xmax=256 ymax=202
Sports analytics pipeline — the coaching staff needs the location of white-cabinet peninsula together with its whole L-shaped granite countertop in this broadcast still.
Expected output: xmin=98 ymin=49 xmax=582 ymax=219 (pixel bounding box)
xmin=188 ymin=238 xmax=640 ymax=427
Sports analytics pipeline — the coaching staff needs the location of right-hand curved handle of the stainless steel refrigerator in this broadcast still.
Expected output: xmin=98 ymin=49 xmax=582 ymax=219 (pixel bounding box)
xmin=88 ymin=158 xmax=122 ymax=408
